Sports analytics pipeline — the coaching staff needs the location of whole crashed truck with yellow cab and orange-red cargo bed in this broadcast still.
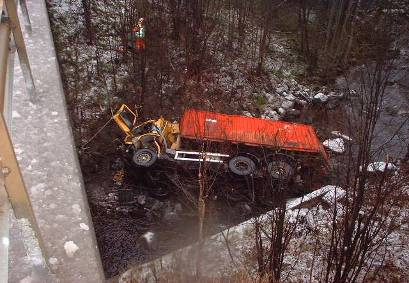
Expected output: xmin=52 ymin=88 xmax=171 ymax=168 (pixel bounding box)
xmin=114 ymin=105 xmax=328 ymax=180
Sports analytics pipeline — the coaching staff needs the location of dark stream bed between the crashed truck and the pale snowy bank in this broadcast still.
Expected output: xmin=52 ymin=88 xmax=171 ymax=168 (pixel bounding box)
xmin=84 ymin=140 xmax=326 ymax=277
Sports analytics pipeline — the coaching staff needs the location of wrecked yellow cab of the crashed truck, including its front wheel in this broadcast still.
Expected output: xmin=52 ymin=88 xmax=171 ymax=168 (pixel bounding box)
xmin=113 ymin=104 xmax=180 ymax=167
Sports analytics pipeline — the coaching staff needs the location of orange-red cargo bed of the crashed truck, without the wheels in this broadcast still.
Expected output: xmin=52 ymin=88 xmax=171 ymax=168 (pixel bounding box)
xmin=180 ymin=109 xmax=328 ymax=161
